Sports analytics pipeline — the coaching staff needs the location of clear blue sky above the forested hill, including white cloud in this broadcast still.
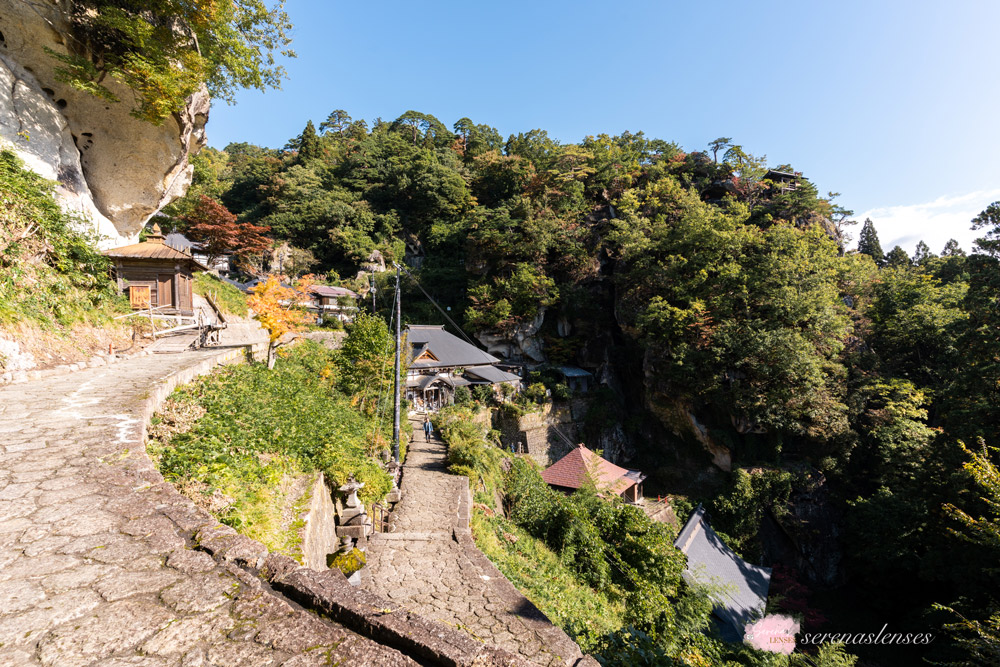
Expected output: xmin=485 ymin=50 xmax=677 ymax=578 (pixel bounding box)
xmin=208 ymin=0 xmax=1000 ymax=252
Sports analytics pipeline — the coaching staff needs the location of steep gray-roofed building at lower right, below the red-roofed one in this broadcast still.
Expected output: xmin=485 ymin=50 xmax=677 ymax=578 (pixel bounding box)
xmin=674 ymin=505 xmax=771 ymax=641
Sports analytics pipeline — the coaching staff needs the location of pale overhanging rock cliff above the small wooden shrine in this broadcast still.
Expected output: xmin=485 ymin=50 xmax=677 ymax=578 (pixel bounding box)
xmin=0 ymin=0 xmax=210 ymax=247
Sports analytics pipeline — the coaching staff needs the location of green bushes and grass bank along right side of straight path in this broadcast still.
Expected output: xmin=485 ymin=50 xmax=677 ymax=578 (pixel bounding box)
xmin=438 ymin=405 xmax=780 ymax=666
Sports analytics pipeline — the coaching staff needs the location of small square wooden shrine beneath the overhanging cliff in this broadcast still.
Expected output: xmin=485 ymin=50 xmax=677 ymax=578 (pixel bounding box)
xmin=104 ymin=225 xmax=208 ymax=315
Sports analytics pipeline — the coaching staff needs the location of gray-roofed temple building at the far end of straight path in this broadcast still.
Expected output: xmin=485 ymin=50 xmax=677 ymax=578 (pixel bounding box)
xmin=406 ymin=324 xmax=521 ymax=411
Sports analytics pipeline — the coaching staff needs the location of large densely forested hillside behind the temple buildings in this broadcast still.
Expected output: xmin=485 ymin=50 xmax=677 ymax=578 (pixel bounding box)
xmin=168 ymin=110 xmax=1000 ymax=664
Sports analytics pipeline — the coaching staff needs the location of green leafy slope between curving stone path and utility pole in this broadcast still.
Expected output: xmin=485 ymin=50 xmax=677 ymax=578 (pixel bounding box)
xmin=148 ymin=341 xmax=392 ymax=556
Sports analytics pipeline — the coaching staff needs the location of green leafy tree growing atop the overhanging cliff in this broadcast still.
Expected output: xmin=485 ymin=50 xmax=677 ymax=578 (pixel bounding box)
xmin=49 ymin=0 xmax=294 ymax=125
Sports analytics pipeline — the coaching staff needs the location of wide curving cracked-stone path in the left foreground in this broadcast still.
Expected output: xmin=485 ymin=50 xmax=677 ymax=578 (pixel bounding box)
xmin=0 ymin=352 xmax=416 ymax=667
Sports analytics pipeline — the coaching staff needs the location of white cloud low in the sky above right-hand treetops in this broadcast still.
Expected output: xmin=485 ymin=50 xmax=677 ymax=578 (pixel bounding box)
xmin=849 ymin=189 xmax=1000 ymax=254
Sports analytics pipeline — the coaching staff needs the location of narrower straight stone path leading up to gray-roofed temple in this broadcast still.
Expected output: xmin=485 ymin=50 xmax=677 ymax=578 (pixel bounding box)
xmin=367 ymin=422 xmax=584 ymax=667
